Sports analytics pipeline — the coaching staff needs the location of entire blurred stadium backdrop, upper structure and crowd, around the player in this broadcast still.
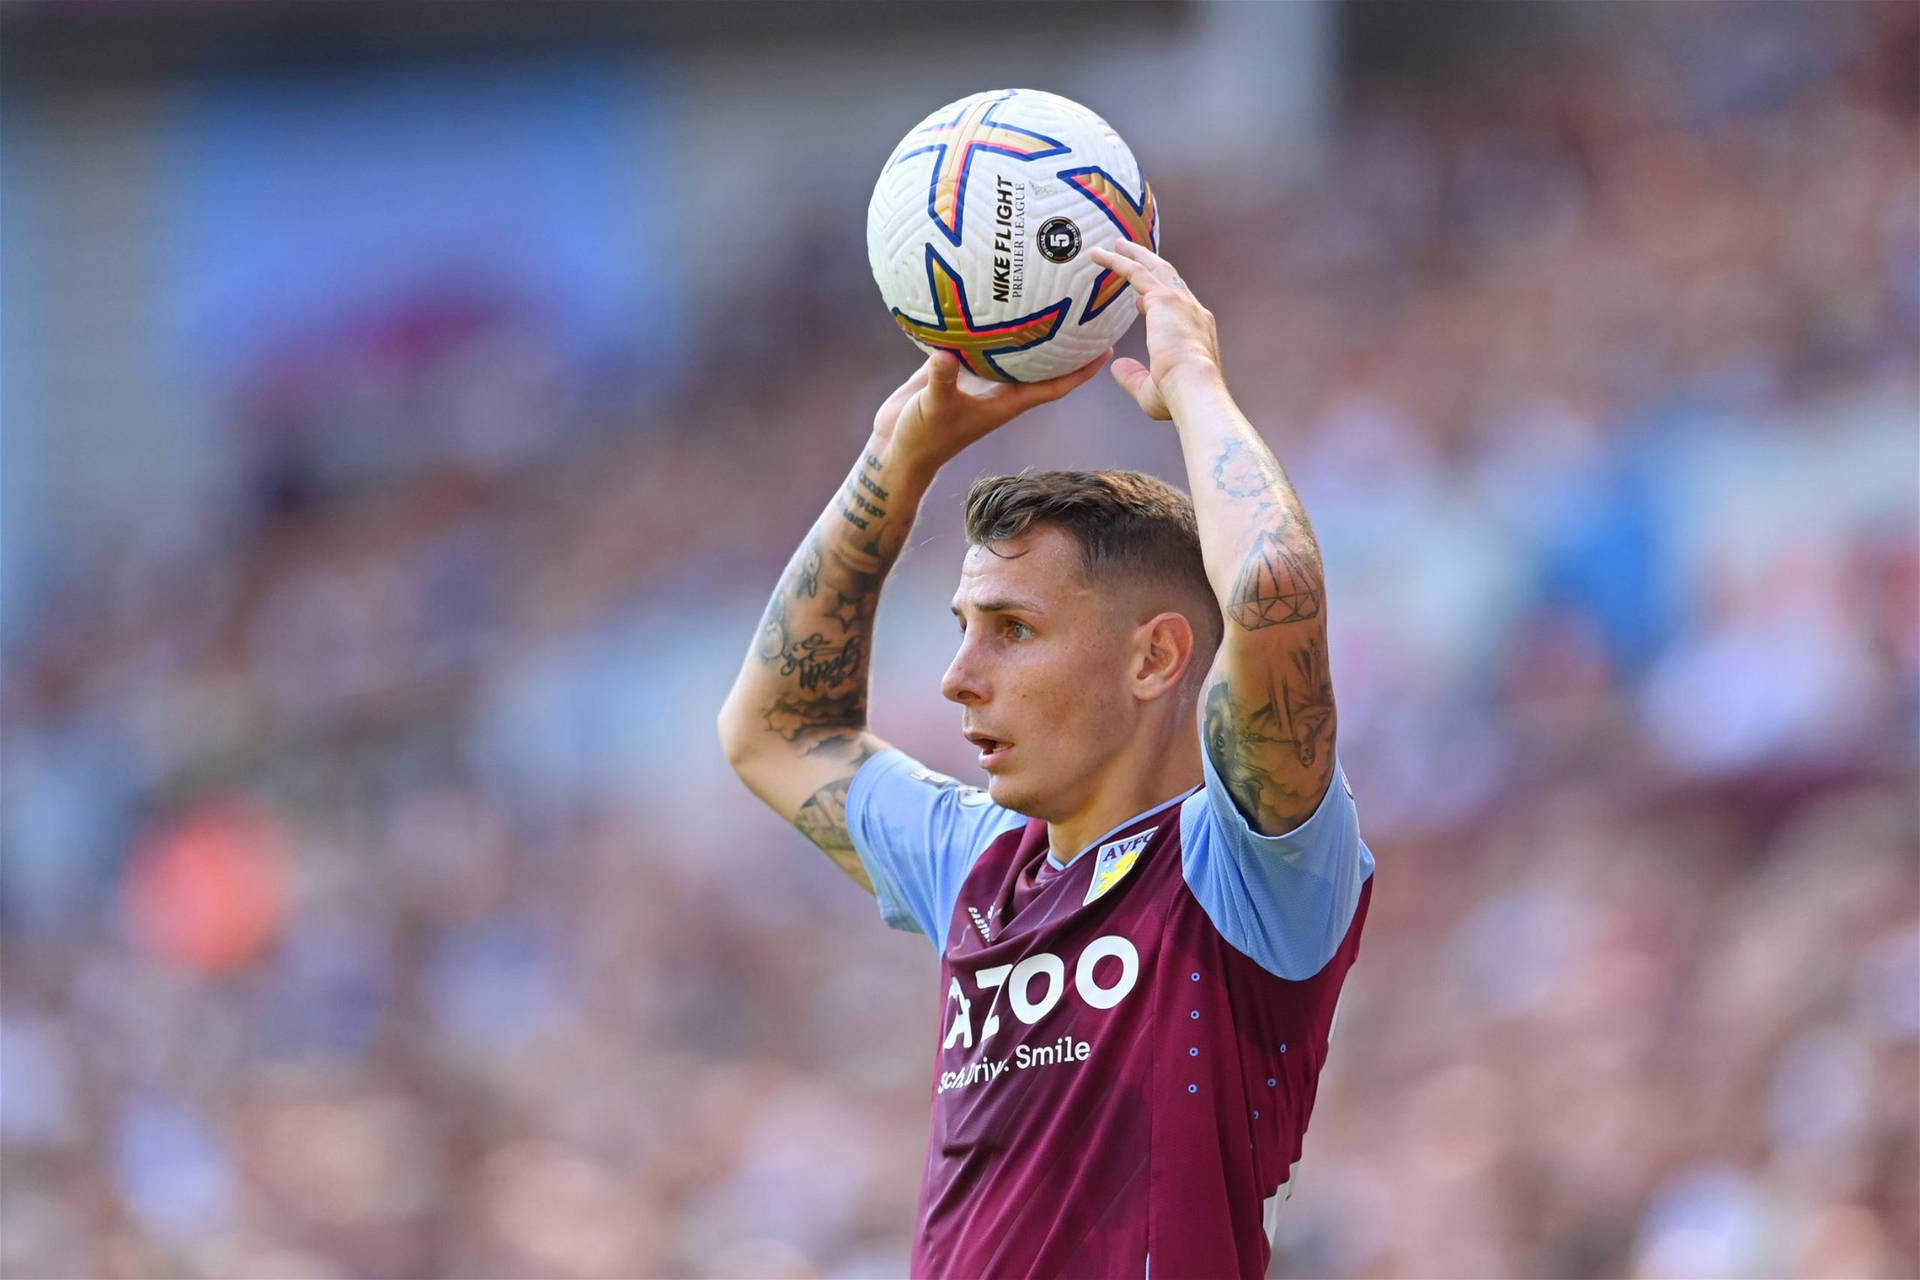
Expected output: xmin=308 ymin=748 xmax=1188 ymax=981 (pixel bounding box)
xmin=0 ymin=0 xmax=1920 ymax=1276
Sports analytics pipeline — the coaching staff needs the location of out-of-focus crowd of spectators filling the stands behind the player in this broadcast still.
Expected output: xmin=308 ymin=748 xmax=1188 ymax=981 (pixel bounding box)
xmin=0 ymin=6 xmax=1920 ymax=1276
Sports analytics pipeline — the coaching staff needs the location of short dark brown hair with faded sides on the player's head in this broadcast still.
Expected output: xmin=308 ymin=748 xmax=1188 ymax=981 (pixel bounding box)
xmin=966 ymin=470 xmax=1223 ymax=666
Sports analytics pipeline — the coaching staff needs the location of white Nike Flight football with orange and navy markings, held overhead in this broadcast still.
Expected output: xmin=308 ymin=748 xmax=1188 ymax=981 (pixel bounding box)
xmin=866 ymin=88 xmax=1160 ymax=382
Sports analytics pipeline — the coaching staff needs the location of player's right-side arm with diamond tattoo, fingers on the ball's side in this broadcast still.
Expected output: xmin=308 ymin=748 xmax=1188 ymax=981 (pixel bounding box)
xmin=1092 ymin=244 xmax=1334 ymax=835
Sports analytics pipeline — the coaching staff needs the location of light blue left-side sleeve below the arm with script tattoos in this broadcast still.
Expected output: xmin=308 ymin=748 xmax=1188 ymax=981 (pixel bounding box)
xmin=847 ymin=748 xmax=1027 ymax=948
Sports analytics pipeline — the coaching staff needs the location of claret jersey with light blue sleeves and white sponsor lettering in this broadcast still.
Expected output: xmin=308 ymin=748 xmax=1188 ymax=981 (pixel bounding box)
xmin=847 ymin=750 xmax=1373 ymax=1278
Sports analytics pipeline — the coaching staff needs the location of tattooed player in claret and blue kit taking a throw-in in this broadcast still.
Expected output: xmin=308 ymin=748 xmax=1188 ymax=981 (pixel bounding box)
xmin=720 ymin=244 xmax=1373 ymax=1278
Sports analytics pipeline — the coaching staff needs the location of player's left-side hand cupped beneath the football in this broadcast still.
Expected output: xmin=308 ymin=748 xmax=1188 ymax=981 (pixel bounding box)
xmin=874 ymin=349 xmax=1114 ymax=468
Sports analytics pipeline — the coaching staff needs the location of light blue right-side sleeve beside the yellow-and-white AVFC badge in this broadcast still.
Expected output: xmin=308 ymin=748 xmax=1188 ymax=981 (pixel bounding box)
xmin=1181 ymin=750 xmax=1373 ymax=983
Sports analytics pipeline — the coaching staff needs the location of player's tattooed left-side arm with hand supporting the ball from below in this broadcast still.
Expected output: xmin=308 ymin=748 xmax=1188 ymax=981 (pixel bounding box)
xmin=720 ymin=355 xmax=1106 ymax=890
